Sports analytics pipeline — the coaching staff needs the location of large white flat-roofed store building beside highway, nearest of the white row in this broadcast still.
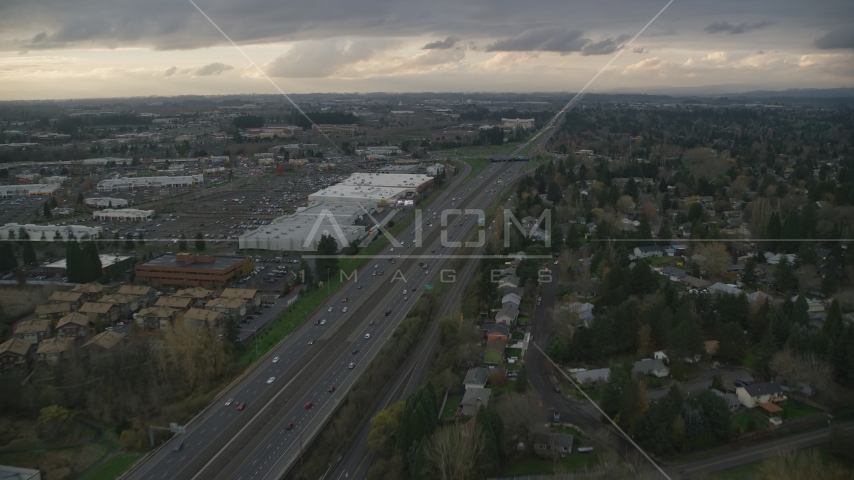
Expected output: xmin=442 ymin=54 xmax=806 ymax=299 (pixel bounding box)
xmin=238 ymin=202 xmax=366 ymax=252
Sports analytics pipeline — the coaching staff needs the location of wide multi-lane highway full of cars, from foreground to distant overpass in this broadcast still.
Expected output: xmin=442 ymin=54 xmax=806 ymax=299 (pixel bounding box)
xmin=128 ymin=159 xmax=519 ymax=479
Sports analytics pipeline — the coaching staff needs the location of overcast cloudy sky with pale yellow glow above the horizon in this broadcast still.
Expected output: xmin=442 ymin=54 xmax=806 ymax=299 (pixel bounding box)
xmin=0 ymin=0 xmax=854 ymax=100
